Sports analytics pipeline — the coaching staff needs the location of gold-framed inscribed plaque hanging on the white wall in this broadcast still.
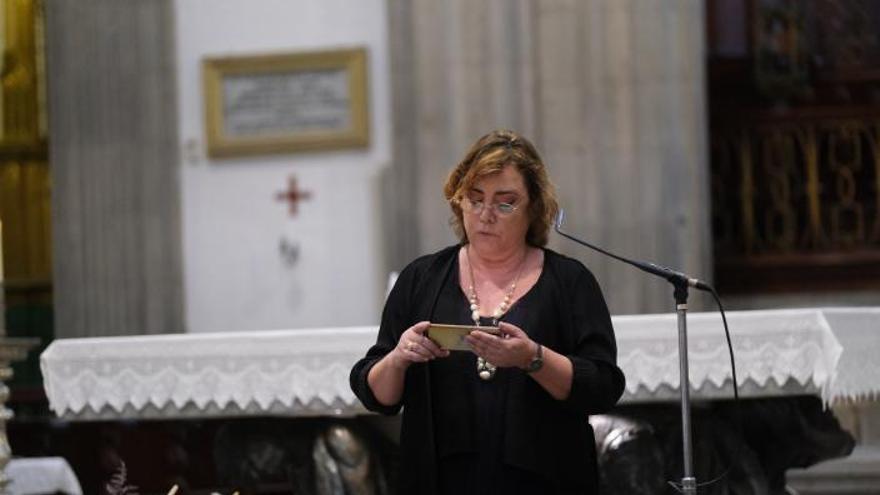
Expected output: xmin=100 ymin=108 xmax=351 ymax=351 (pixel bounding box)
xmin=202 ymin=48 xmax=370 ymax=158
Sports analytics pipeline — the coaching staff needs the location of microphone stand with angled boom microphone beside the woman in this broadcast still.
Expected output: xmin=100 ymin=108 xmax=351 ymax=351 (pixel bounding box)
xmin=556 ymin=209 xmax=711 ymax=495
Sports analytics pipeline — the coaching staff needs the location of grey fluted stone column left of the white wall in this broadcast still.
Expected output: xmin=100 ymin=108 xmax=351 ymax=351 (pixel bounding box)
xmin=46 ymin=0 xmax=183 ymax=337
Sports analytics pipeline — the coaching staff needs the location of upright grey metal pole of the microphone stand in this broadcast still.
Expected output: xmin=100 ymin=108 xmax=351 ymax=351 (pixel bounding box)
xmin=671 ymin=280 xmax=697 ymax=495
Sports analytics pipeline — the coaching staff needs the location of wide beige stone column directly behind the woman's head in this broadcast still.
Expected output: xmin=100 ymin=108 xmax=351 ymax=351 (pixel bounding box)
xmin=386 ymin=0 xmax=712 ymax=313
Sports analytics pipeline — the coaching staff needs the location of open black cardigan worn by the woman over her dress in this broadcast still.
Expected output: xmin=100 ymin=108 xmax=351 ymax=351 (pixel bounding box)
xmin=350 ymin=245 xmax=624 ymax=494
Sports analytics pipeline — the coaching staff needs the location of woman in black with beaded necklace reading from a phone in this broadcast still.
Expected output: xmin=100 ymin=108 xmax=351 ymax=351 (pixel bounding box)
xmin=351 ymin=131 xmax=624 ymax=495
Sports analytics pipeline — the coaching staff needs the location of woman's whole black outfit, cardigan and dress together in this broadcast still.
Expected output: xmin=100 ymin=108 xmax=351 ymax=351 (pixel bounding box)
xmin=351 ymin=246 xmax=624 ymax=495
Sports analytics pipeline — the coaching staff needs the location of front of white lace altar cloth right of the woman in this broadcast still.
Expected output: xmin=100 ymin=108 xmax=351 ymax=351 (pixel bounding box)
xmin=615 ymin=310 xmax=843 ymax=401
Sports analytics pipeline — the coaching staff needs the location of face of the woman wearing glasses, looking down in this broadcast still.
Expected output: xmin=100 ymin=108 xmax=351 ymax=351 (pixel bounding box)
xmin=461 ymin=165 xmax=529 ymax=254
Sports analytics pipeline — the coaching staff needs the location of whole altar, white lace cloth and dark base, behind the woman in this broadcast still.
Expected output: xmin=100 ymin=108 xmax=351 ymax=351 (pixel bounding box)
xmin=41 ymin=307 xmax=880 ymax=494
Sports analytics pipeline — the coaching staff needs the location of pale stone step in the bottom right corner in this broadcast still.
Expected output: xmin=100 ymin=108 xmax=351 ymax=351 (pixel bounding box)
xmin=787 ymin=445 xmax=880 ymax=495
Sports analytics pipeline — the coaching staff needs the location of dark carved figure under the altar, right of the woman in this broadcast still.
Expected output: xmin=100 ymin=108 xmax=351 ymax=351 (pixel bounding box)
xmin=591 ymin=396 xmax=855 ymax=495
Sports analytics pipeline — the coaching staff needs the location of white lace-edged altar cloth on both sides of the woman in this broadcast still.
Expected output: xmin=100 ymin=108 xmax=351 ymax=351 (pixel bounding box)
xmin=40 ymin=308 xmax=880 ymax=419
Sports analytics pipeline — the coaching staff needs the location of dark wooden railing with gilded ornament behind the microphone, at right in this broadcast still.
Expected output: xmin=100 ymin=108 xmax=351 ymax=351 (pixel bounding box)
xmin=711 ymin=109 xmax=880 ymax=292
